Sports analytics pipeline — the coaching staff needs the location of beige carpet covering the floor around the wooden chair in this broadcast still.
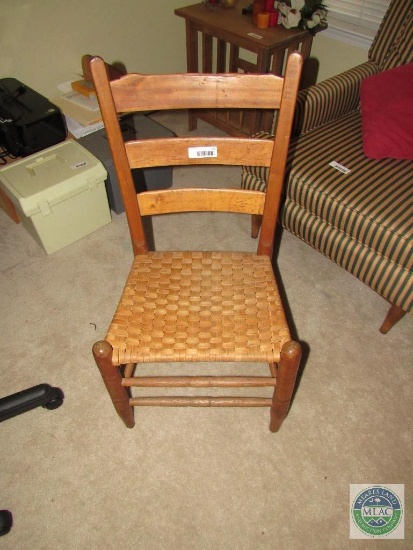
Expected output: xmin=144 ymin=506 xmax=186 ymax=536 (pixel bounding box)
xmin=0 ymin=116 xmax=413 ymax=550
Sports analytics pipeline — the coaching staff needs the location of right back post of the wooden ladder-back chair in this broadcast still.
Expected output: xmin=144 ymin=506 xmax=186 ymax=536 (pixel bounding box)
xmin=257 ymin=52 xmax=303 ymax=258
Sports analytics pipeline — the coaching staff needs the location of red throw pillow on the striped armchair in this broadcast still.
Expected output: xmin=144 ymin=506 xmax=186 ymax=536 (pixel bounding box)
xmin=360 ymin=63 xmax=413 ymax=160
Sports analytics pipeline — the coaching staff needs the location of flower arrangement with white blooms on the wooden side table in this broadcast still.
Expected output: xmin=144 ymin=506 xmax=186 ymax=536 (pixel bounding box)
xmin=275 ymin=0 xmax=328 ymax=34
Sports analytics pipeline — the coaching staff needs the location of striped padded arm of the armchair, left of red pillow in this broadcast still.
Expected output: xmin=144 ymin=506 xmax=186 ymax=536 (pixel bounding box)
xmin=293 ymin=61 xmax=378 ymax=136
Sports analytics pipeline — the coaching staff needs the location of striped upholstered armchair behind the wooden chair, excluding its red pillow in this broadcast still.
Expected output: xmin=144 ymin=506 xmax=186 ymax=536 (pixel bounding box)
xmin=241 ymin=0 xmax=413 ymax=333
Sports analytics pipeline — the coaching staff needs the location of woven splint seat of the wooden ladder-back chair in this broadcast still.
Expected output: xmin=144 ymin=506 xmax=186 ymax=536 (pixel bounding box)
xmin=106 ymin=252 xmax=290 ymax=365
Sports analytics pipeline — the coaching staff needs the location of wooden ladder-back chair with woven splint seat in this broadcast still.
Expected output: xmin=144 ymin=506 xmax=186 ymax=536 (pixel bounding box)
xmin=90 ymin=53 xmax=302 ymax=432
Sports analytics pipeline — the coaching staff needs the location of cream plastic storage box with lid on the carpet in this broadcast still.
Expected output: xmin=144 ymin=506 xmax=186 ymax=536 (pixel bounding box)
xmin=0 ymin=140 xmax=111 ymax=254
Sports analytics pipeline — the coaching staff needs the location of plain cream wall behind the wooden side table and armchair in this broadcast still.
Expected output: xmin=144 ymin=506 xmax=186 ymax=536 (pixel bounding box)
xmin=0 ymin=0 xmax=367 ymax=97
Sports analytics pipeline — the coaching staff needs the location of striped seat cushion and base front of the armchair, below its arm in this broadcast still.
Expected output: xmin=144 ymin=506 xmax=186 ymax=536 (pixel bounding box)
xmin=282 ymin=111 xmax=413 ymax=311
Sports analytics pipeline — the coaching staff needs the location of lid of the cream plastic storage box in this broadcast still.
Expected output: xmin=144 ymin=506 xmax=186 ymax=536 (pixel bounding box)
xmin=0 ymin=139 xmax=107 ymax=216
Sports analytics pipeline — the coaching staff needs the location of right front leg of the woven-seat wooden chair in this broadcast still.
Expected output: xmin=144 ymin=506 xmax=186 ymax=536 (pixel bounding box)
xmin=270 ymin=341 xmax=301 ymax=432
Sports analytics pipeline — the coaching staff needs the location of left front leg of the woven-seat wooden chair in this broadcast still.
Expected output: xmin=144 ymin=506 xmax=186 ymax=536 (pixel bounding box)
xmin=92 ymin=340 xmax=135 ymax=428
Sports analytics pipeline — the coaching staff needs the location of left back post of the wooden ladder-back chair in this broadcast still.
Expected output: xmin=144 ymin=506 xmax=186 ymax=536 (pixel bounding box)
xmin=90 ymin=57 xmax=148 ymax=255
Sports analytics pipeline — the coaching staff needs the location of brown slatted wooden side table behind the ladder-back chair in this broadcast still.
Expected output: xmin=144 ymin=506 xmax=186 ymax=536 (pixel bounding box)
xmin=174 ymin=0 xmax=313 ymax=136
